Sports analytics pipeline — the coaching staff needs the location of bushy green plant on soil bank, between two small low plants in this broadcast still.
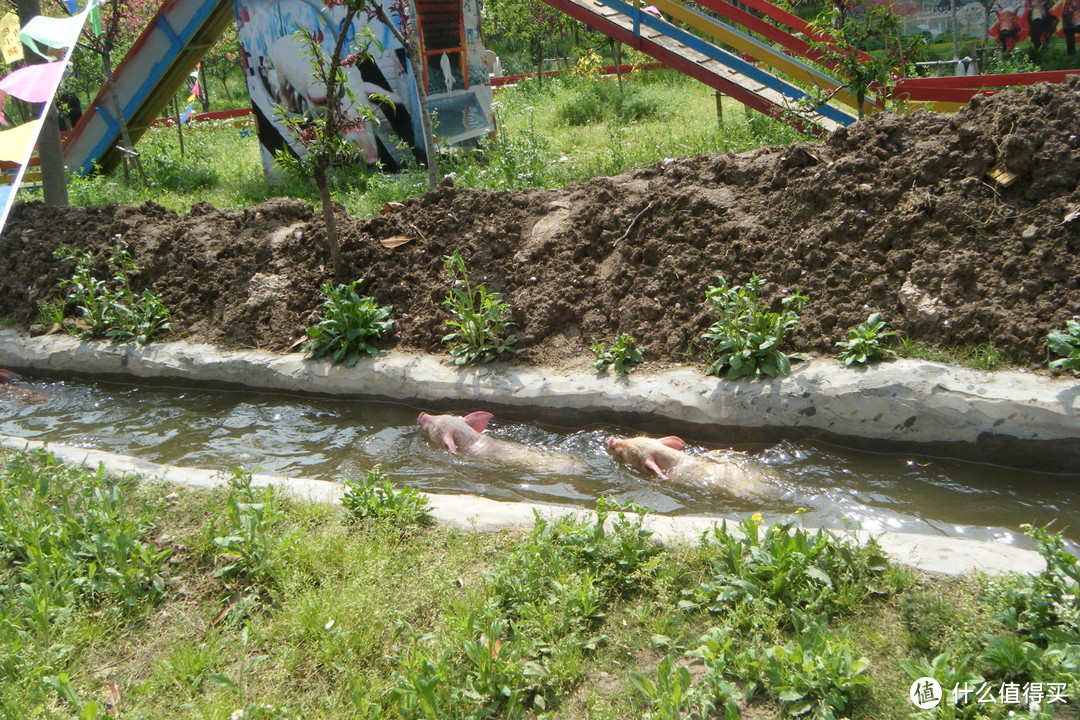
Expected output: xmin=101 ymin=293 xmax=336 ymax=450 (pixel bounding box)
xmin=702 ymin=274 xmax=808 ymax=380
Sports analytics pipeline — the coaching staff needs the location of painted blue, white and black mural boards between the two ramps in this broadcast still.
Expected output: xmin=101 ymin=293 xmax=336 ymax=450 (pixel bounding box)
xmin=233 ymin=0 xmax=494 ymax=176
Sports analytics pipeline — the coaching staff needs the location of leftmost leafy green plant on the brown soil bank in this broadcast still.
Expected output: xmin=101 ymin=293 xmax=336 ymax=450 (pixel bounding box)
xmin=55 ymin=240 xmax=172 ymax=345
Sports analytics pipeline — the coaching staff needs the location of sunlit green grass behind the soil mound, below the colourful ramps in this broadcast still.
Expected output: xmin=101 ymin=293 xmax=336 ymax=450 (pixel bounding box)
xmin=35 ymin=70 xmax=801 ymax=216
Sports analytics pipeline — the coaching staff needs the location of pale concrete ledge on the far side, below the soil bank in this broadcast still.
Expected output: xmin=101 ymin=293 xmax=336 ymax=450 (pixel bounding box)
xmin=0 ymin=328 xmax=1080 ymax=473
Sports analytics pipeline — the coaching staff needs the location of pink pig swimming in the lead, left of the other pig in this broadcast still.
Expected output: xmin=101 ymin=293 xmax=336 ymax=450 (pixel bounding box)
xmin=416 ymin=410 xmax=582 ymax=475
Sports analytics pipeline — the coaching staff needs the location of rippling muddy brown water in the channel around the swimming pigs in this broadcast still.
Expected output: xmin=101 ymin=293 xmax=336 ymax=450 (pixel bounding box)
xmin=0 ymin=381 xmax=1080 ymax=545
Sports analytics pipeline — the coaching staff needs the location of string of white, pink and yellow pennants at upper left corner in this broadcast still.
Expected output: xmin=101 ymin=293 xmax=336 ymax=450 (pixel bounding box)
xmin=0 ymin=0 xmax=98 ymax=231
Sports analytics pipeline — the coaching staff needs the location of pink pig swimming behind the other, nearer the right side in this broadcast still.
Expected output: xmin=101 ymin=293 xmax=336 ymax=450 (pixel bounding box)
xmin=607 ymin=435 xmax=781 ymax=500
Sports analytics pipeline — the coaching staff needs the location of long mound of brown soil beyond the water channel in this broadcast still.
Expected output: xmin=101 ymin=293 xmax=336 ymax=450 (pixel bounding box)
xmin=0 ymin=76 xmax=1080 ymax=371
